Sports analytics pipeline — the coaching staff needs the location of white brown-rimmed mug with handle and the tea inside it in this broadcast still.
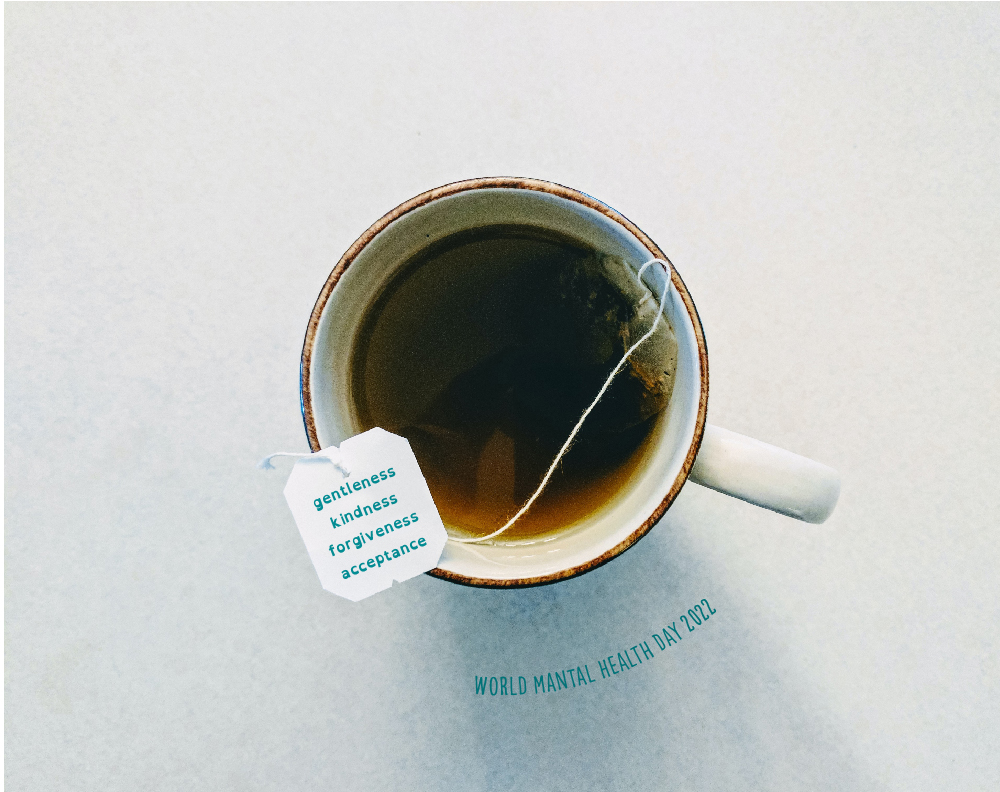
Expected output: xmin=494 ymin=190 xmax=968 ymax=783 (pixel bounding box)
xmin=300 ymin=178 xmax=840 ymax=587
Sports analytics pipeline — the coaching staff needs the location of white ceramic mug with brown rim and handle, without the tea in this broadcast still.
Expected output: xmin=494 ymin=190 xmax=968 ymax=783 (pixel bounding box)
xmin=300 ymin=178 xmax=840 ymax=587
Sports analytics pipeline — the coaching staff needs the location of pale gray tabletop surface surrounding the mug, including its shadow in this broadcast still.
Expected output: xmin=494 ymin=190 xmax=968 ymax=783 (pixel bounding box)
xmin=5 ymin=4 xmax=1000 ymax=790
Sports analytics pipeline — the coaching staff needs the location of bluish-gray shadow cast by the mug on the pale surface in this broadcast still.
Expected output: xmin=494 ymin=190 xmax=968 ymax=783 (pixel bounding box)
xmin=416 ymin=493 xmax=870 ymax=790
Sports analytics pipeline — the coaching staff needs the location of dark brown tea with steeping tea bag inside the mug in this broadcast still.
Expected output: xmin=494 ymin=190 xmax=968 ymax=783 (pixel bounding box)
xmin=352 ymin=226 xmax=677 ymax=542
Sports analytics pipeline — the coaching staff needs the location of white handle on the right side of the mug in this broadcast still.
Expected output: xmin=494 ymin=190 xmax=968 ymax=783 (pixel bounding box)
xmin=688 ymin=424 xmax=840 ymax=523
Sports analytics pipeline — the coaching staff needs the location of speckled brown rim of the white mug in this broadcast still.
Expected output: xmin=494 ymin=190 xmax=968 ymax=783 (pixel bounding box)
xmin=299 ymin=176 xmax=708 ymax=588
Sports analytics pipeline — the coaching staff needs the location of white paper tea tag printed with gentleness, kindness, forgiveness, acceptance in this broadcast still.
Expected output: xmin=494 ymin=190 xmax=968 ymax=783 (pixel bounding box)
xmin=285 ymin=427 xmax=448 ymax=602
